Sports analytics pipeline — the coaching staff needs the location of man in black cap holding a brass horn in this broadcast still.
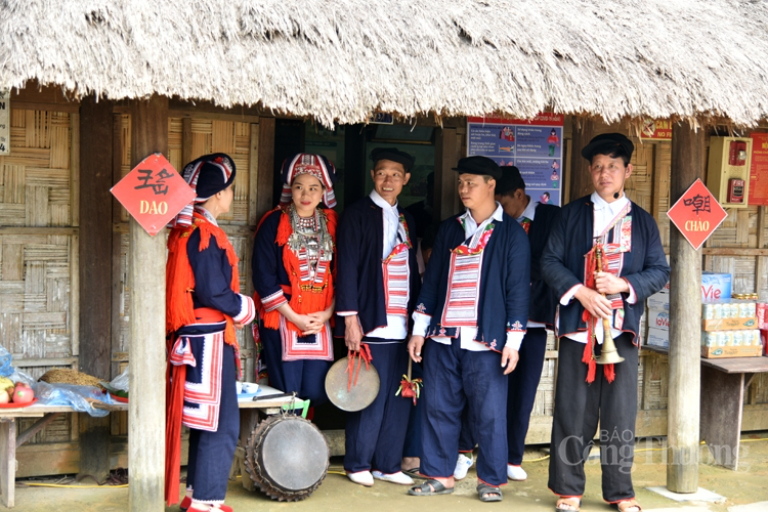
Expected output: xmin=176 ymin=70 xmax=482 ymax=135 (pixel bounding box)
xmin=541 ymin=133 xmax=669 ymax=512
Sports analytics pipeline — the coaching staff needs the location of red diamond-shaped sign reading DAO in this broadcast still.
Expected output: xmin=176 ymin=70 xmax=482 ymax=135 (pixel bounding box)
xmin=111 ymin=153 xmax=195 ymax=236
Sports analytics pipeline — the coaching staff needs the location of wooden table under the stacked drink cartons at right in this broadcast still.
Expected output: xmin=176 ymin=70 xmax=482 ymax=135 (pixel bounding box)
xmin=642 ymin=345 xmax=768 ymax=471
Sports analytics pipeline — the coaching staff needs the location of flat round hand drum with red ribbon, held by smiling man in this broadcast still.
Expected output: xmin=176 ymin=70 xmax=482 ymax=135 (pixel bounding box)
xmin=325 ymin=357 xmax=381 ymax=412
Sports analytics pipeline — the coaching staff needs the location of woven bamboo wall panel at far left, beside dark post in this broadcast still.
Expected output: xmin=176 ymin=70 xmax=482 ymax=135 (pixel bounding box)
xmin=0 ymin=105 xmax=79 ymax=444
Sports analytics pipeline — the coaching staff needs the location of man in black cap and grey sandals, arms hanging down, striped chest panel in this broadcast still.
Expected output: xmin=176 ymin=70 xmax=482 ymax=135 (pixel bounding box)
xmin=408 ymin=156 xmax=530 ymax=501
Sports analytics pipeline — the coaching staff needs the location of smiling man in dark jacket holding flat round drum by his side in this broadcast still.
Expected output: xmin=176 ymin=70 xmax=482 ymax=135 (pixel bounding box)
xmin=336 ymin=148 xmax=421 ymax=486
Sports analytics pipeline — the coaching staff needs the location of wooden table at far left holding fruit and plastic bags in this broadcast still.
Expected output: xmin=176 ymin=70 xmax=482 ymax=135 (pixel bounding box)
xmin=0 ymin=402 xmax=128 ymax=508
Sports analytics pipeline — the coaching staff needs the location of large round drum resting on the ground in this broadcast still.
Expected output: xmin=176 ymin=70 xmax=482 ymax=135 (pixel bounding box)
xmin=245 ymin=414 xmax=331 ymax=501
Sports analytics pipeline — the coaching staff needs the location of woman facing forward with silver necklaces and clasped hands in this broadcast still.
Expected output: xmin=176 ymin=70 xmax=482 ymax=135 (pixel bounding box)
xmin=252 ymin=153 xmax=337 ymax=405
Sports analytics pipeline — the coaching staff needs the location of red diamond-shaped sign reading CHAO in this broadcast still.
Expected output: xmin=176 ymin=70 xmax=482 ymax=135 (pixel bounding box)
xmin=667 ymin=179 xmax=728 ymax=250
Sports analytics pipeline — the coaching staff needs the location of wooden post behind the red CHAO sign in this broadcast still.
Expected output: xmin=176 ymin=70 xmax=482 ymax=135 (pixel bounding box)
xmin=667 ymin=122 xmax=706 ymax=493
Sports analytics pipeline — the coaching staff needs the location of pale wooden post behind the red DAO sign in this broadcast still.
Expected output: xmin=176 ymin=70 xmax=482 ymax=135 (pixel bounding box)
xmin=128 ymin=95 xmax=168 ymax=512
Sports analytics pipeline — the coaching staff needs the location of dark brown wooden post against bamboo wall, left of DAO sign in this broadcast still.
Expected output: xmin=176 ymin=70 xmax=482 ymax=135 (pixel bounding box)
xmin=79 ymin=95 xmax=113 ymax=481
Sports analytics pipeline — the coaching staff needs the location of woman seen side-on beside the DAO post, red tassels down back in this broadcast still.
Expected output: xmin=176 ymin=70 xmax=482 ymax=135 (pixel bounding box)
xmin=165 ymin=153 xmax=256 ymax=512
